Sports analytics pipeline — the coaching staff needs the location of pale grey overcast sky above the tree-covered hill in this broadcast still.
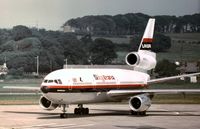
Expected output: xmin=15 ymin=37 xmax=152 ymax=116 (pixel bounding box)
xmin=0 ymin=0 xmax=200 ymax=30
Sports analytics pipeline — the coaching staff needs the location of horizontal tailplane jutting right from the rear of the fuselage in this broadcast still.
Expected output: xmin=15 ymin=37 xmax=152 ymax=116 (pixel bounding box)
xmin=147 ymin=73 xmax=200 ymax=84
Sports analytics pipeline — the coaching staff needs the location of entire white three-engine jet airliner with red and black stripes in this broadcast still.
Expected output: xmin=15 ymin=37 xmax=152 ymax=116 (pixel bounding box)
xmin=4 ymin=18 xmax=200 ymax=118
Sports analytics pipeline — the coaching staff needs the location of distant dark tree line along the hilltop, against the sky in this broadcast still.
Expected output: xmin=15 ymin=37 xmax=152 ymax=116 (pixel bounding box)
xmin=63 ymin=13 xmax=200 ymax=35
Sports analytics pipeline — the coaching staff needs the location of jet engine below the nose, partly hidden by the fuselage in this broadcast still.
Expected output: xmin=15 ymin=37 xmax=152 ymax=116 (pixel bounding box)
xmin=39 ymin=96 xmax=58 ymax=110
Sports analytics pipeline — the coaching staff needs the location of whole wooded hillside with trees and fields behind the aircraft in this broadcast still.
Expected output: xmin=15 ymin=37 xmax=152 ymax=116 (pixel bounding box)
xmin=0 ymin=13 xmax=200 ymax=74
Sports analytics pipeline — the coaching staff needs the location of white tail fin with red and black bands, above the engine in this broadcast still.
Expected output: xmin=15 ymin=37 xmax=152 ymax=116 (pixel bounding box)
xmin=138 ymin=18 xmax=155 ymax=51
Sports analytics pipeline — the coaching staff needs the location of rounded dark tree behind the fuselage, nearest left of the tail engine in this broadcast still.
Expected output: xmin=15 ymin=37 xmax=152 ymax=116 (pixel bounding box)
xmin=89 ymin=38 xmax=117 ymax=64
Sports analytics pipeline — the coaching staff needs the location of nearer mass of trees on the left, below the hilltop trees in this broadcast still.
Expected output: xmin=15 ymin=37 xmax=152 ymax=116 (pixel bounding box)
xmin=0 ymin=25 xmax=117 ymax=74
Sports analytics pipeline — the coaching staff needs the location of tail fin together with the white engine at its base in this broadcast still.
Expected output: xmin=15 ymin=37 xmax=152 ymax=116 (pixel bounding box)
xmin=125 ymin=18 xmax=157 ymax=72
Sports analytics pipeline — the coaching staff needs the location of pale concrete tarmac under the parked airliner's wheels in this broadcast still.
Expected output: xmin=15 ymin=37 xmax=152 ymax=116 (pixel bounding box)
xmin=0 ymin=103 xmax=200 ymax=129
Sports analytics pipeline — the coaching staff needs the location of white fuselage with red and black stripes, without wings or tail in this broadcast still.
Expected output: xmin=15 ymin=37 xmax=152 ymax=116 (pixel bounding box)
xmin=41 ymin=69 xmax=149 ymax=104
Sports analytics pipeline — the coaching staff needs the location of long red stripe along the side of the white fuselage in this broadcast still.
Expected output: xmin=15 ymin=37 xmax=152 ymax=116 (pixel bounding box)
xmin=44 ymin=84 xmax=147 ymax=89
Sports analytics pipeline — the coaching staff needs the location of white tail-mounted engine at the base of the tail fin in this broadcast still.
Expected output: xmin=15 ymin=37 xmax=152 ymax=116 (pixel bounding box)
xmin=125 ymin=50 xmax=156 ymax=70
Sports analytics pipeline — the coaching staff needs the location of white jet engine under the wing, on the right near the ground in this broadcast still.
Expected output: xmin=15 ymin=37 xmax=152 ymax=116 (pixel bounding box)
xmin=129 ymin=94 xmax=151 ymax=112
